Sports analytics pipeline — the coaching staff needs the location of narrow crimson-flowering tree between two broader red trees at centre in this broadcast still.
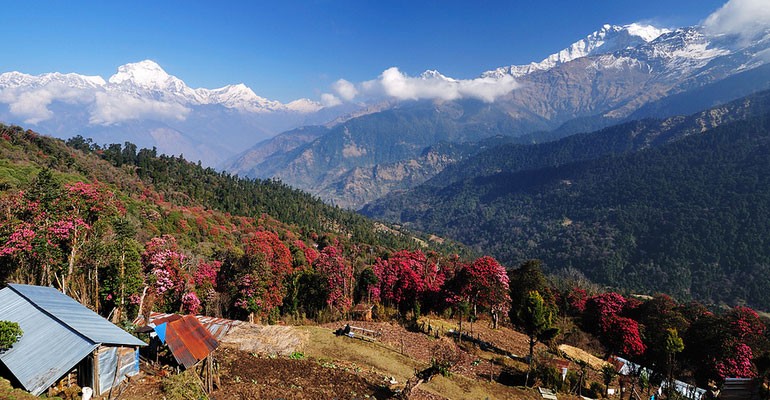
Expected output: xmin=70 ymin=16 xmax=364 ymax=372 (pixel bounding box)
xmin=313 ymin=246 xmax=353 ymax=313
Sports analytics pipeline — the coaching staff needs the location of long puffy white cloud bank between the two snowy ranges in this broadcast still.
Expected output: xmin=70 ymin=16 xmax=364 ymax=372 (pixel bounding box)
xmin=322 ymin=67 xmax=518 ymax=104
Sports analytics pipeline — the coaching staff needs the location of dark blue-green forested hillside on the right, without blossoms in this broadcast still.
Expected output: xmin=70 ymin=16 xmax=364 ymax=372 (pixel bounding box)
xmin=364 ymin=93 xmax=770 ymax=309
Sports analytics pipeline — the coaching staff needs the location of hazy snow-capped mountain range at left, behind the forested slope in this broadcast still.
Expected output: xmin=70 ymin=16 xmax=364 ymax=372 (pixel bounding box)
xmin=0 ymin=60 xmax=356 ymax=165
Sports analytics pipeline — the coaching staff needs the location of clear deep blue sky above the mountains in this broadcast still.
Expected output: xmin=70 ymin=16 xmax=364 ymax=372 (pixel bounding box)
xmin=0 ymin=0 xmax=725 ymax=102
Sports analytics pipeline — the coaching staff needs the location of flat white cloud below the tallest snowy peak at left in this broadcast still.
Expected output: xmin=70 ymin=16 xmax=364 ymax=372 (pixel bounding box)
xmin=88 ymin=92 xmax=190 ymax=125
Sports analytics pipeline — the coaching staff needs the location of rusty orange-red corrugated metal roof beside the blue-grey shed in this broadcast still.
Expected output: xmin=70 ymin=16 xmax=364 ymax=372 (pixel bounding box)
xmin=166 ymin=315 xmax=219 ymax=368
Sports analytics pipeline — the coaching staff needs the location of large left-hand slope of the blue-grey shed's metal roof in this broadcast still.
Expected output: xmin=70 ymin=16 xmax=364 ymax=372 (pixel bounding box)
xmin=0 ymin=288 xmax=99 ymax=396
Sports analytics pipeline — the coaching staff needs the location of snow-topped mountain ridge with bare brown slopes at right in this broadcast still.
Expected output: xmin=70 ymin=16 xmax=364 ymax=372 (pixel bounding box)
xmin=231 ymin=24 xmax=770 ymax=208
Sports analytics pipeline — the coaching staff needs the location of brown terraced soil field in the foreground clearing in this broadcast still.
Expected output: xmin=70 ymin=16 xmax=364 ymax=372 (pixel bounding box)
xmin=120 ymin=318 xmax=596 ymax=400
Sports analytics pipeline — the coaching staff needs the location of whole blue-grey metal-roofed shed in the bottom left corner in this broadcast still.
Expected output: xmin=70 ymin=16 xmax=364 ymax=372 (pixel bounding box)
xmin=0 ymin=284 xmax=145 ymax=396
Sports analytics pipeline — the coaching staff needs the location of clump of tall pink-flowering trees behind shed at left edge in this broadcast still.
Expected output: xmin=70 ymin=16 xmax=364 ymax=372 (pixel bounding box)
xmin=0 ymin=170 xmax=122 ymax=302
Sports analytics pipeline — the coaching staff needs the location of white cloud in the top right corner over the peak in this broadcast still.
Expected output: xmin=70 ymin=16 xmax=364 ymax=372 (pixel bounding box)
xmin=703 ymin=0 xmax=770 ymax=40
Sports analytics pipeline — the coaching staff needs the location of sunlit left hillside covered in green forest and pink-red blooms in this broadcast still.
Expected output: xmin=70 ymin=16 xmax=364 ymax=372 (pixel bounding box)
xmin=0 ymin=126 xmax=459 ymax=321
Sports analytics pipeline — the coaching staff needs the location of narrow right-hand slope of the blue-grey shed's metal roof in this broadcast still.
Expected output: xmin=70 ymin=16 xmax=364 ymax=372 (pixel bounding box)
xmin=8 ymin=284 xmax=145 ymax=346
